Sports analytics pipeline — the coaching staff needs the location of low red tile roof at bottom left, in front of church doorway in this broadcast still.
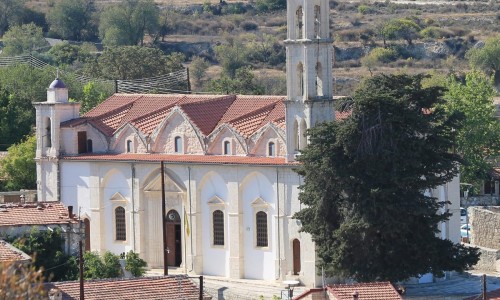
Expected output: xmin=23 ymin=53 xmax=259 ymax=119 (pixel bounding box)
xmin=45 ymin=275 xmax=211 ymax=300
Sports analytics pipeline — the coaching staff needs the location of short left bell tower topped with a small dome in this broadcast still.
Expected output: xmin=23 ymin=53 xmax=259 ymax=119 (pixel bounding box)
xmin=33 ymin=78 xmax=80 ymax=201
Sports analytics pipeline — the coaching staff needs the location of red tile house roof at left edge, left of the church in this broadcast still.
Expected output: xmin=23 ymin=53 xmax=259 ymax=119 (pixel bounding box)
xmin=0 ymin=202 xmax=76 ymax=227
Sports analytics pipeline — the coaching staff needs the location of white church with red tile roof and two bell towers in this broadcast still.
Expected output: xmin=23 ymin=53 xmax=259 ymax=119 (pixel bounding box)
xmin=34 ymin=0 xmax=459 ymax=286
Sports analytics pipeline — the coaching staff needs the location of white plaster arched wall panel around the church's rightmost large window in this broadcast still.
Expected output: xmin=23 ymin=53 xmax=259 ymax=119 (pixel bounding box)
xmin=240 ymin=172 xmax=276 ymax=280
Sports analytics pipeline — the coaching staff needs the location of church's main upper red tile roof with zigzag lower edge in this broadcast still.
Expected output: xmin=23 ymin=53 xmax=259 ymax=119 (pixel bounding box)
xmin=61 ymin=94 xmax=286 ymax=137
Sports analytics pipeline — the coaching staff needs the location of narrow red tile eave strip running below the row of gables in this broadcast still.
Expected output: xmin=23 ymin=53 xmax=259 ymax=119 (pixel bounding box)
xmin=62 ymin=153 xmax=289 ymax=166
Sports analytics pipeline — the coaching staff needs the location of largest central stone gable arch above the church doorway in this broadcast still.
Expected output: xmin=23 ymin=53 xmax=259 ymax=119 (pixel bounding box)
xmin=151 ymin=106 xmax=206 ymax=154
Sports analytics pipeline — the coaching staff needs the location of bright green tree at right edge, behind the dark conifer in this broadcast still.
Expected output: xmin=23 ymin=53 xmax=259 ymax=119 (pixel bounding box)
xmin=445 ymin=71 xmax=500 ymax=184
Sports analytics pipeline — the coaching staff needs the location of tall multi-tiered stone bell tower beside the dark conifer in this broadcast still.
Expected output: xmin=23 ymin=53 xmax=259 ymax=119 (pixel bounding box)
xmin=285 ymin=0 xmax=335 ymax=161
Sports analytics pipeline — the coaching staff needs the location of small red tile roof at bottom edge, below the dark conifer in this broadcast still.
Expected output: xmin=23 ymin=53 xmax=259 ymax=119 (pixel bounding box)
xmin=294 ymin=282 xmax=403 ymax=300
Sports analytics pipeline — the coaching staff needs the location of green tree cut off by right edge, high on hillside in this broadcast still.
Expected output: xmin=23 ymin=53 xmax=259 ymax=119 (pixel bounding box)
xmin=465 ymin=35 xmax=500 ymax=83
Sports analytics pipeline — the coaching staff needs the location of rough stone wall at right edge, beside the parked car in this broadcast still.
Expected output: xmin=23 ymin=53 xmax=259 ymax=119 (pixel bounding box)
xmin=468 ymin=206 xmax=500 ymax=250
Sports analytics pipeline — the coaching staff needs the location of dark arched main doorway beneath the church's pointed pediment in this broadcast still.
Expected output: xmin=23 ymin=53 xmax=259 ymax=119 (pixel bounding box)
xmin=165 ymin=209 xmax=182 ymax=267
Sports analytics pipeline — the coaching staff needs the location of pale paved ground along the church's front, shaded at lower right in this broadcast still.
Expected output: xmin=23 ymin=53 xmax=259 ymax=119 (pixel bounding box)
xmin=147 ymin=269 xmax=500 ymax=300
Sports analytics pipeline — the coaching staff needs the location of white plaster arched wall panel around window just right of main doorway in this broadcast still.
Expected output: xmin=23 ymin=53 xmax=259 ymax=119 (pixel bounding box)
xmin=199 ymin=172 xmax=231 ymax=276
